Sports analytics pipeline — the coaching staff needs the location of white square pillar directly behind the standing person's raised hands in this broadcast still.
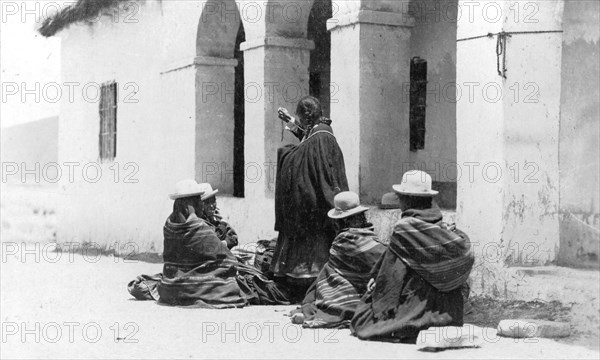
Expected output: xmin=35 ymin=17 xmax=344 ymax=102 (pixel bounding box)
xmin=240 ymin=36 xmax=314 ymax=199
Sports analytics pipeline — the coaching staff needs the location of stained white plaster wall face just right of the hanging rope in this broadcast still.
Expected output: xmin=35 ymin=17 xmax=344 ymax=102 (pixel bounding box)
xmin=501 ymin=25 xmax=562 ymax=265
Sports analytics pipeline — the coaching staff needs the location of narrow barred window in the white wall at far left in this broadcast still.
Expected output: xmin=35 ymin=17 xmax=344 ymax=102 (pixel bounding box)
xmin=98 ymin=81 xmax=117 ymax=162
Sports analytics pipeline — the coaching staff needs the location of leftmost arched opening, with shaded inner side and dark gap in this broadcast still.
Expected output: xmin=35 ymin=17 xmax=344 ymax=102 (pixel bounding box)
xmin=194 ymin=0 xmax=245 ymax=197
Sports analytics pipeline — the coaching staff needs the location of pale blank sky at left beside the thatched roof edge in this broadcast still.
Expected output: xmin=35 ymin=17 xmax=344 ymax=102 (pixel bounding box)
xmin=0 ymin=0 xmax=62 ymax=127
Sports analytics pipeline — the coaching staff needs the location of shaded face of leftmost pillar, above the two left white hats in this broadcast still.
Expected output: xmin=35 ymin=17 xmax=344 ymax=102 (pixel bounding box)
xmin=194 ymin=56 xmax=237 ymax=194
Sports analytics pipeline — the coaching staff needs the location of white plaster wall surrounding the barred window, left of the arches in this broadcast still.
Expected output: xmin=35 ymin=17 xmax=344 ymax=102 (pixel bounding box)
xmin=58 ymin=2 xmax=194 ymax=251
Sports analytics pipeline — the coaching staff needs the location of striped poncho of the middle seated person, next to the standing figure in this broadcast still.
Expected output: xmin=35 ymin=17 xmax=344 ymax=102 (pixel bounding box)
xmin=292 ymin=224 xmax=386 ymax=328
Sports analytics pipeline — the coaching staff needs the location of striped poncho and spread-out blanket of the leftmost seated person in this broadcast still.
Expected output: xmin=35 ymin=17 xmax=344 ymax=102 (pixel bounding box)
xmin=128 ymin=214 xmax=289 ymax=309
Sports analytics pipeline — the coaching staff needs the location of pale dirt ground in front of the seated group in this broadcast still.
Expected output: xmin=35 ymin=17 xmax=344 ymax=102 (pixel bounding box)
xmin=0 ymin=184 xmax=600 ymax=359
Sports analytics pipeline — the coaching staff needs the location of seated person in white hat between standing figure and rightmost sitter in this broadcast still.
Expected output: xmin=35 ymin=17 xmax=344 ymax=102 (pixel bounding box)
xmin=290 ymin=191 xmax=386 ymax=328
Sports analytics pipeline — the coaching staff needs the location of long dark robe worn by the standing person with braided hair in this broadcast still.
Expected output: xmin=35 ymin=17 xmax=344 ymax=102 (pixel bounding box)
xmin=271 ymin=123 xmax=348 ymax=278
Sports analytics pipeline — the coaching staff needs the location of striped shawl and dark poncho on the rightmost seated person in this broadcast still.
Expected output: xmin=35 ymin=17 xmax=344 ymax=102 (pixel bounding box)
xmin=351 ymin=209 xmax=474 ymax=342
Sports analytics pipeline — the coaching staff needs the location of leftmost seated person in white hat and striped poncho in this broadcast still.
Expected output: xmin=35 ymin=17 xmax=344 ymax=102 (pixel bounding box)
xmin=158 ymin=180 xmax=247 ymax=308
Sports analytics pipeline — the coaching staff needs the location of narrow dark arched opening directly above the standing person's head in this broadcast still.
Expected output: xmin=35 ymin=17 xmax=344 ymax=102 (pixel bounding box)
xmin=307 ymin=0 xmax=334 ymax=117
